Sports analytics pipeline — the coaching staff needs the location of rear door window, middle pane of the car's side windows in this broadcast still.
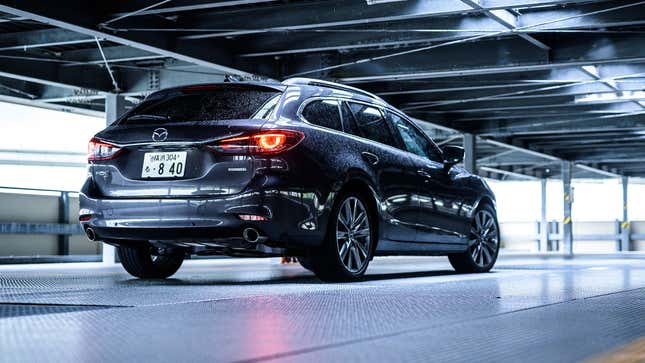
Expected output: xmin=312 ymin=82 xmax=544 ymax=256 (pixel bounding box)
xmin=348 ymin=102 xmax=397 ymax=147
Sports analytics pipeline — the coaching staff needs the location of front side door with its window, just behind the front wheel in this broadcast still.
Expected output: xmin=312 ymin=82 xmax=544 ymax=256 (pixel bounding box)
xmin=388 ymin=113 xmax=465 ymax=243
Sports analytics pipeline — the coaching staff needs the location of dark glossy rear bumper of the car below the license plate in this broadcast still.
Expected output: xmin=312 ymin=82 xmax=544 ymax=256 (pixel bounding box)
xmin=79 ymin=190 xmax=326 ymax=252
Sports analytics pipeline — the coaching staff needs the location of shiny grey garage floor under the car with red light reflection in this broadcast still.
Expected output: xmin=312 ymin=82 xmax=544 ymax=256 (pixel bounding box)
xmin=0 ymin=257 xmax=645 ymax=363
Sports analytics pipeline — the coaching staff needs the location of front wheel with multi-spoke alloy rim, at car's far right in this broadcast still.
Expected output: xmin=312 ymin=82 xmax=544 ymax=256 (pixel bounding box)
xmin=448 ymin=204 xmax=499 ymax=273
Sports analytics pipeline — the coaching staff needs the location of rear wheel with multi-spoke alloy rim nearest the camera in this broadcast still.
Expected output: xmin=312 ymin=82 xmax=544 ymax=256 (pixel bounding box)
xmin=305 ymin=191 xmax=378 ymax=282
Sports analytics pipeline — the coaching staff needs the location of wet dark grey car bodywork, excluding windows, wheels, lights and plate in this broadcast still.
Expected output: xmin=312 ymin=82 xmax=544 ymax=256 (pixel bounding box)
xmin=80 ymin=80 xmax=495 ymax=264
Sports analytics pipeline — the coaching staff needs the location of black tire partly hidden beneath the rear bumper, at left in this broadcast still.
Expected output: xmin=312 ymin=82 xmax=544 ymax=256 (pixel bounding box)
xmin=117 ymin=246 xmax=184 ymax=279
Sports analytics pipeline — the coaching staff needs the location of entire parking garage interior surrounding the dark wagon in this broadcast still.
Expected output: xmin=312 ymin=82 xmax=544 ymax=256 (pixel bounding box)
xmin=0 ymin=0 xmax=645 ymax=362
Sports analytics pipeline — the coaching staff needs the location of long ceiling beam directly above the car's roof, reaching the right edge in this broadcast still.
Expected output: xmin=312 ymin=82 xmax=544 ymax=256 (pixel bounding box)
xmin=332 ymin=34 xmax=645 ymax=84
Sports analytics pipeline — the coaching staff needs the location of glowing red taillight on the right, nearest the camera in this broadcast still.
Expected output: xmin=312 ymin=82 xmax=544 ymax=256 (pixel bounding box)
xmin=208 ymin=130 xmax=305 ymax=155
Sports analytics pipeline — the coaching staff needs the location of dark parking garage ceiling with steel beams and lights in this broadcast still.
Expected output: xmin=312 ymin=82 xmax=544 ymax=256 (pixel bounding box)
xmin=0 ymin=0 xmax=645 ymax=178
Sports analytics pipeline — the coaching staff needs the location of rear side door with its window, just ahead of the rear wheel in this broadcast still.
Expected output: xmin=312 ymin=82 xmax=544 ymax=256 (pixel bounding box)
xmin=341 ymin=102 xmax=418 ymax=247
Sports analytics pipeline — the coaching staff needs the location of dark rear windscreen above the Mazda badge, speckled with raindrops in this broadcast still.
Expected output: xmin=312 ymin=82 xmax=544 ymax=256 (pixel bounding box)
xmin=121 ymin=87 xmax=281 ymax=124
